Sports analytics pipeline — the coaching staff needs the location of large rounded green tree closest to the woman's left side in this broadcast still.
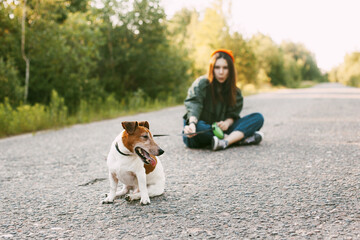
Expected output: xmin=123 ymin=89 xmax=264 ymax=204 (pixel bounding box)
xmin=97 ymin=0 xmax=189 ymax=100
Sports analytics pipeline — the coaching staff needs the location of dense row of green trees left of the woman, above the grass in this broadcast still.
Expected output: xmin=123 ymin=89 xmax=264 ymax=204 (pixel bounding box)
xmin=0 ymin=0 xmax=190 ymax=114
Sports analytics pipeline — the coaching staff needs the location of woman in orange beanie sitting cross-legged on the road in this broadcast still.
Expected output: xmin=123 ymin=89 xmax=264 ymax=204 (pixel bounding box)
xmin=183 ymin=49 xmax=264 ymax=151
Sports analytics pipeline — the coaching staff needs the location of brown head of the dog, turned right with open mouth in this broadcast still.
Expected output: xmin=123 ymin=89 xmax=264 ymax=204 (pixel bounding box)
xmin=121 ymin=121 xmax=164 ymax=165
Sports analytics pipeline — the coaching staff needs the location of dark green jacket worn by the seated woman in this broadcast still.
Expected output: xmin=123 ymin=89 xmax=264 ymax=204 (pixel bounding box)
xmin=184 ymin=76 xmax=243 ymax=124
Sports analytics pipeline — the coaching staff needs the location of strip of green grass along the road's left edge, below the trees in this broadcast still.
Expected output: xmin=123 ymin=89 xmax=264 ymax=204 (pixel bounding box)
xmin=0 ymin=91 xmax=180 ymax=138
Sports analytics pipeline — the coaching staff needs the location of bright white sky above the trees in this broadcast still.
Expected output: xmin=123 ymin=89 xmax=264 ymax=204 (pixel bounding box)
xmin=161 ymin=0 xmax=360 ymax=72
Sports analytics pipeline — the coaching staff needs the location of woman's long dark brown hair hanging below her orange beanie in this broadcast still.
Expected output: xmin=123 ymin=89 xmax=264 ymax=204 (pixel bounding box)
xmin=208 ymin=52 xmax=236 ymax=106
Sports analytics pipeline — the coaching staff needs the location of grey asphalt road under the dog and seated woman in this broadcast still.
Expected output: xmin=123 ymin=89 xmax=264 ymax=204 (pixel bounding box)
xmin=0 ymin=84 xmax=360 ymax=239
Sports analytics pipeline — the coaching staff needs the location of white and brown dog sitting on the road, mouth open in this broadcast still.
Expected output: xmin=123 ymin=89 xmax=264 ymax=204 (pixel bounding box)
xmin=102 ymin=121 xmax=165 ymax=205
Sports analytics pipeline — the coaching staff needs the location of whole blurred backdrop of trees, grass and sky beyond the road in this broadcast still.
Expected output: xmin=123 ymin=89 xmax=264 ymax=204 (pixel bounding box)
xmin=0 ymin=0 xmax=360 ymax=137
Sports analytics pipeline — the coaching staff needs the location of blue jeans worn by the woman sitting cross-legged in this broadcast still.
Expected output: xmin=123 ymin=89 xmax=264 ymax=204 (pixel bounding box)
xmin=183 ymin=113 xmax=264 ymax=148
